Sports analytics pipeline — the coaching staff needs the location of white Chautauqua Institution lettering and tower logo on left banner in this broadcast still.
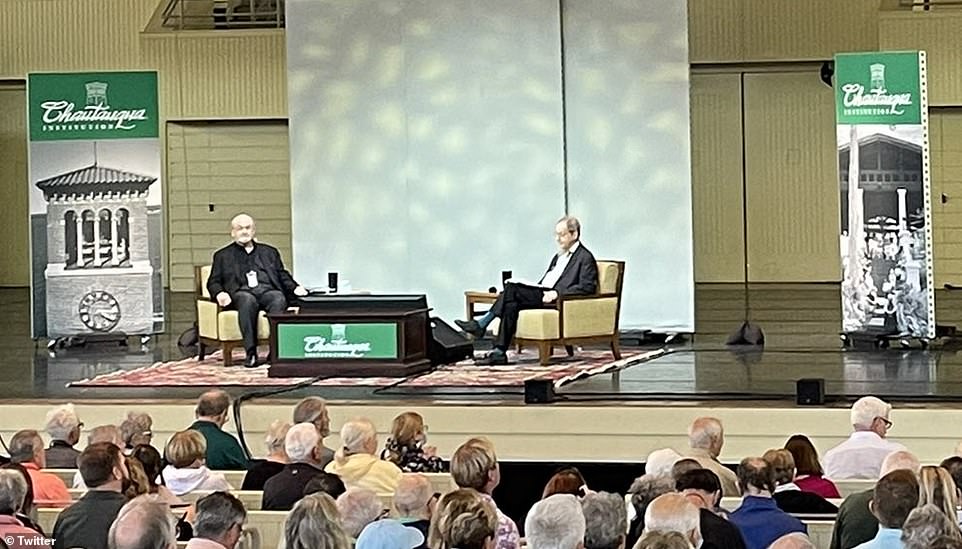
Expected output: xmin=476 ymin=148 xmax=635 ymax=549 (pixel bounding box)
xmin=40 ymin=82 xmax=147 ymax=132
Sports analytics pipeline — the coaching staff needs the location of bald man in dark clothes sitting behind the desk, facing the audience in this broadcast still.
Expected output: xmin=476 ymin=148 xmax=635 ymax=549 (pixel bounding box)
xmin=207 ymin=214 xmax=307 ymax=368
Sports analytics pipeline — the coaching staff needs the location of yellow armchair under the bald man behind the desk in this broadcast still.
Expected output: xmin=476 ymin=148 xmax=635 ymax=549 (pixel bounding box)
xmin=194 ymin=265 xmax=271 ymax=366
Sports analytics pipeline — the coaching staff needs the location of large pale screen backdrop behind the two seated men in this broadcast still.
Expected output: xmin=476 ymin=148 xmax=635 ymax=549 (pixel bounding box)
xmin=286 ymin=0 xmax=693 ymax=331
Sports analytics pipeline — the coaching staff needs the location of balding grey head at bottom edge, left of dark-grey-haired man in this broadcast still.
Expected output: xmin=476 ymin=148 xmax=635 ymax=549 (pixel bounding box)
xmin=107 ymin=495 xmax=178 ymax=549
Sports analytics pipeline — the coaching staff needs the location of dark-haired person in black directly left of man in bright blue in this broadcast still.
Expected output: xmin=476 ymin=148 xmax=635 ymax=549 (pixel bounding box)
xmin=675 ymin=469 xmax=745 ymax=549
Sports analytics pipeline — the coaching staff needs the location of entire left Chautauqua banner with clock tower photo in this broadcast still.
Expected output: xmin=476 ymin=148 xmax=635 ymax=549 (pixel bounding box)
xmin=27 ymin=71 xmax=164 ymax=338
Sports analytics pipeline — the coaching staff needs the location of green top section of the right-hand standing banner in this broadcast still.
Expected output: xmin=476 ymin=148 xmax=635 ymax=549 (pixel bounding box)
xmin=835 ymin=51 xmax=922 ymax=125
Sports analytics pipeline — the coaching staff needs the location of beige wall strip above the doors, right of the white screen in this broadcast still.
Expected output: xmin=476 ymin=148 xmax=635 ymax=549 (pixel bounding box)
xmin=688 ymin=0 xmax=879 ymax=63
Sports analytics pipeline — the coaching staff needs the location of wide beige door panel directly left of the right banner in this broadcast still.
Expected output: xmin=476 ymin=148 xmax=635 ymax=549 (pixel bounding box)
xmin=745 ymin=73 xmax=841 ymax=282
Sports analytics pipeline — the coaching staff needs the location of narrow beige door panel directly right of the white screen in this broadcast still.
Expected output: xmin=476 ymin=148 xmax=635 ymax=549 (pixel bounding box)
xmin=691 ymin=74 xmax=744 ymax=282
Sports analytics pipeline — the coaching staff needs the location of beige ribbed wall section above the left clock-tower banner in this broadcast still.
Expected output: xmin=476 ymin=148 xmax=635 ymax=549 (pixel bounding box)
xmin=0 ymin=0 xmax=157 ymax=78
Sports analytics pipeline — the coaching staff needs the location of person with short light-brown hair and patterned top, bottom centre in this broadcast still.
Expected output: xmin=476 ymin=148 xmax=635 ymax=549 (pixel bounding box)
xmin=451 ymin=437 xmax=521 ymax=549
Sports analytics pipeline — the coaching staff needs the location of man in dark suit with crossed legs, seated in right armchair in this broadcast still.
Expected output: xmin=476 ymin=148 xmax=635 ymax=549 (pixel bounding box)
xmin=454 ymin=216 xmax=598 ymax=364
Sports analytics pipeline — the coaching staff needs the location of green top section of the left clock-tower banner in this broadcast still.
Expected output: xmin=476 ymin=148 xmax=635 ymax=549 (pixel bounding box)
xmin=27 ymin=71 xmax=160 ymax=141
